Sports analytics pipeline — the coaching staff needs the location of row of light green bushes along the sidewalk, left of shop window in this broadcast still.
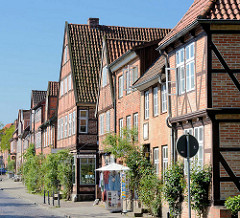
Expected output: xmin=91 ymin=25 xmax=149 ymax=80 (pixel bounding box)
xmin=22 ymin=144 xmax=72 ymax=199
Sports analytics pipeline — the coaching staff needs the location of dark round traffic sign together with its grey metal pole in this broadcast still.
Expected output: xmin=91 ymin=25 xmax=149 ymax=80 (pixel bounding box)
xmin=177 ymin=133 xmax=199 ymax=218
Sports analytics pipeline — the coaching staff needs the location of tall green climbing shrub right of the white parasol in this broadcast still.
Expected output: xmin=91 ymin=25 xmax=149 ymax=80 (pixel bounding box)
xmin=104 ymin=129 xmax=161 ymax=216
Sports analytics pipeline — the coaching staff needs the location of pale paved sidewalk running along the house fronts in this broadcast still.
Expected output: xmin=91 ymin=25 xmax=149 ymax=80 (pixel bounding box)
xmin=0 ymin=176 xmax=132 ymax=218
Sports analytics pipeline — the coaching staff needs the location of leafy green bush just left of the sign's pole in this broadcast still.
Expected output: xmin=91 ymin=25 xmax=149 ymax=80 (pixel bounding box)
xmin=163 ymin=163 xmax=185 ymax=217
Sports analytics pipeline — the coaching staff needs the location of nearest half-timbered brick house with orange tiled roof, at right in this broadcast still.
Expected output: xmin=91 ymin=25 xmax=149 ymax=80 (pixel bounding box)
xmin=158 ymin=0 xmax=240 ymax=217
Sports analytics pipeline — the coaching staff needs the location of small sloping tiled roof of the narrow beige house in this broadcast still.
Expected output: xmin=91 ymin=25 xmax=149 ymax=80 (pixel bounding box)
xmin=133 ymin=56 xmax=165 ymax=88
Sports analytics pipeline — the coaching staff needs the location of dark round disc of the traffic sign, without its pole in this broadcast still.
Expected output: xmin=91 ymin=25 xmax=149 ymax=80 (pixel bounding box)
xmin=177 ymin=135 xmax=199 ymax=158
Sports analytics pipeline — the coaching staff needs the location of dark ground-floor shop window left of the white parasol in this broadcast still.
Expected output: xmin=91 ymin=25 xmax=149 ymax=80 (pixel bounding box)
xmin=80 ymin=158 xmax=96 ymax=185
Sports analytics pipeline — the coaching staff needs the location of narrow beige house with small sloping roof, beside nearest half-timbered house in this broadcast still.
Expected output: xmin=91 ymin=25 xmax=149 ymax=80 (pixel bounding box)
xmin=133 ymin=56 xmax=171 ymax=178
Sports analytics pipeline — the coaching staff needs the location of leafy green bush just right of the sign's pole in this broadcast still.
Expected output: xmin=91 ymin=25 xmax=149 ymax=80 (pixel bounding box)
xmin=190 ymin=167 xmax=211 ymax=216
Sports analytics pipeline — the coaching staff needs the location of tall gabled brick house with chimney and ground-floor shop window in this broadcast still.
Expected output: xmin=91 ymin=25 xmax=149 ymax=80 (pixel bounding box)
xmin=57 ymin=18 xmax=171 ymax=200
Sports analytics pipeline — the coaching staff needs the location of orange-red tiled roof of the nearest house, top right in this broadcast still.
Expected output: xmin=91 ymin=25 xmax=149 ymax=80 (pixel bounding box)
xmin=159 ymin=0 xmax=240 ymax=47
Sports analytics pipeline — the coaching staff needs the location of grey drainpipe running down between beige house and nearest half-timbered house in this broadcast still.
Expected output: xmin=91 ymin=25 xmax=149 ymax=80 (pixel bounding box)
xmin=160 ymin=51 xmax=176 ymax=163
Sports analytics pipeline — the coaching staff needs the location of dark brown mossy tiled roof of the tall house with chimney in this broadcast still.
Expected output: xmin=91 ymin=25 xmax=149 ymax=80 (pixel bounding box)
xmin=67 ymin=21 xmax=169 ymax=103
